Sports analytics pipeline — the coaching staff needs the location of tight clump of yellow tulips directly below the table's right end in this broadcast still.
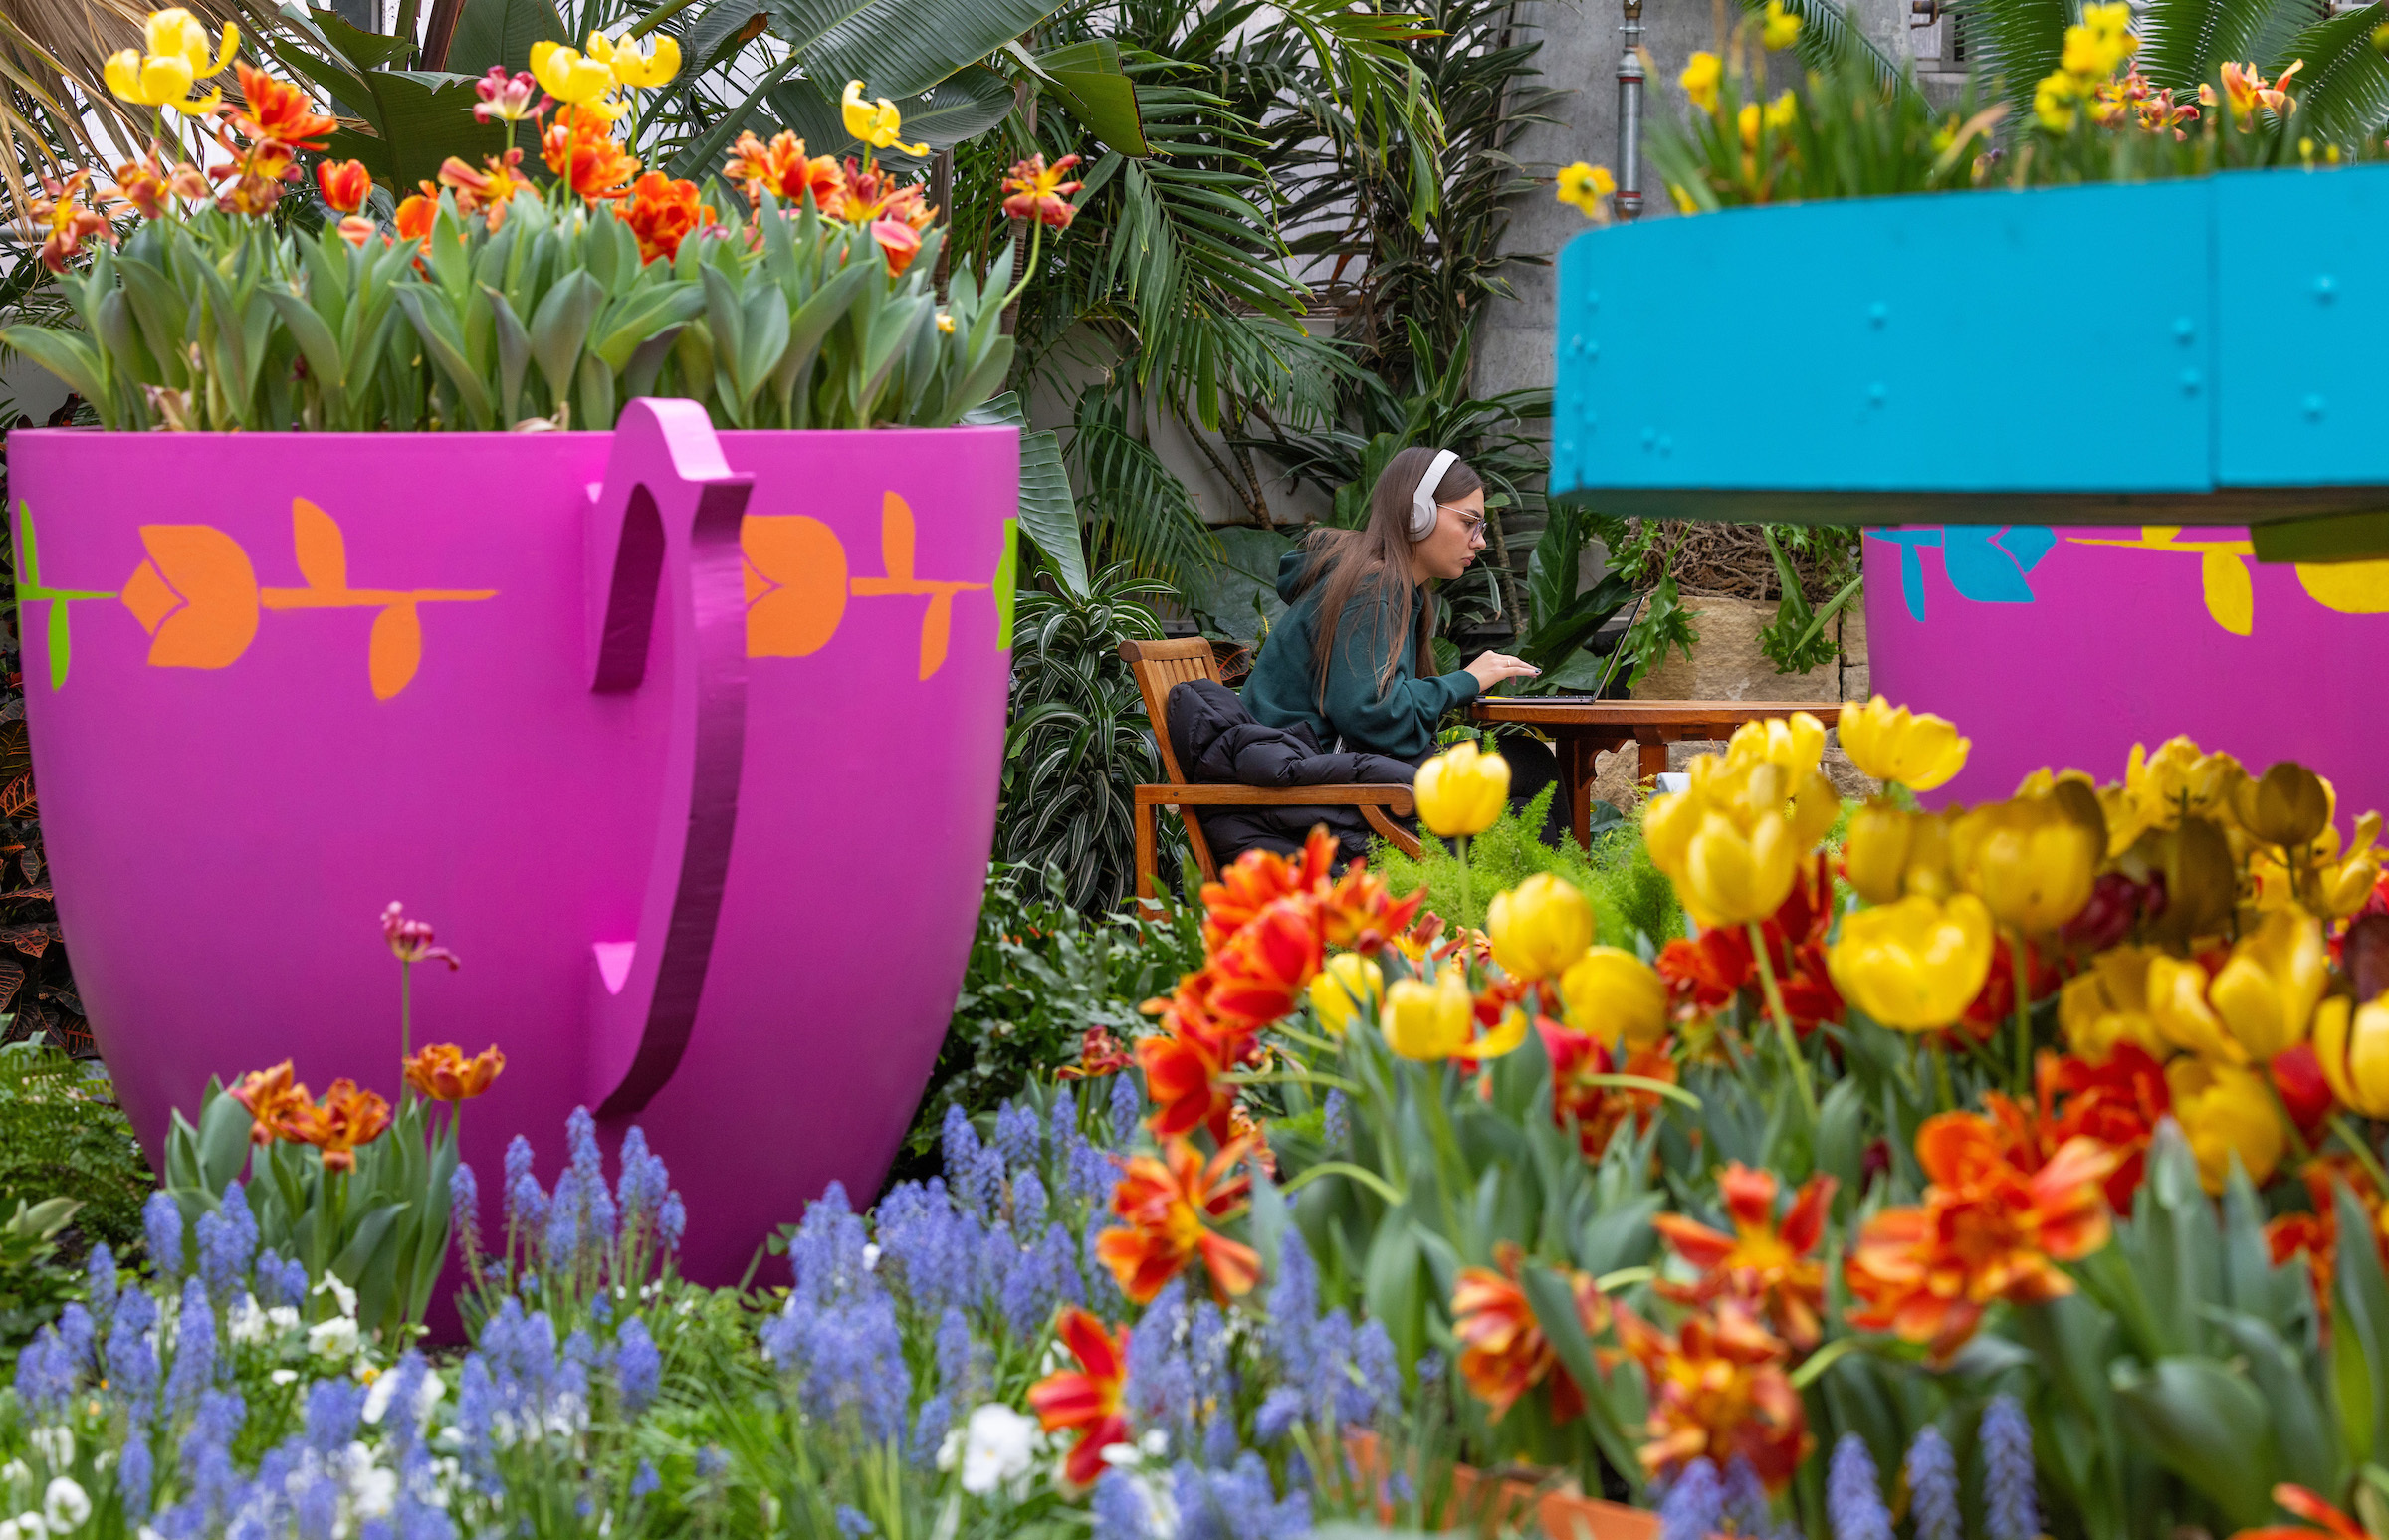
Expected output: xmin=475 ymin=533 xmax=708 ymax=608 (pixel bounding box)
xmin=1643 ymin=712 xmax=1842 ymax=927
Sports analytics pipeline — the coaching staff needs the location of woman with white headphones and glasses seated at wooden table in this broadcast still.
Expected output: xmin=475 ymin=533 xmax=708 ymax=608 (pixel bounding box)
xmin=1244 ymin=447 xmax=1565 ymax=843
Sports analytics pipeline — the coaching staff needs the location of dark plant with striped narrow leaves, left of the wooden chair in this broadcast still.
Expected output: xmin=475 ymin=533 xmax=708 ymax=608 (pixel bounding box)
xmin=996 ymin=565 xmax=1176 ymax=910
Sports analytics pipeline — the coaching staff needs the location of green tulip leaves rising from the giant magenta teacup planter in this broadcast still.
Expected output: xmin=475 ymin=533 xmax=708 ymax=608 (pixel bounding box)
xmin=18 ymin=193 xmax=1013 ymax=430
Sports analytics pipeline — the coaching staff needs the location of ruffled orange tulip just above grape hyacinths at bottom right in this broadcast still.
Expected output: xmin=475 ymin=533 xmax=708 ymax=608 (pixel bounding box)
xmin=1618 ymin=1299 xmax=1816 ymax=1492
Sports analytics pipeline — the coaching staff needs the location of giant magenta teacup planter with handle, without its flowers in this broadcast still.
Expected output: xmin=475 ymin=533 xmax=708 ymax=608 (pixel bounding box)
xmin=10 ymin=401 xmax=1017 ymax=1282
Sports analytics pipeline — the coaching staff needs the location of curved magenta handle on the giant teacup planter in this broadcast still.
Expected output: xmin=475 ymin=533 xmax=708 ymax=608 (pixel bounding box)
xmin=587 ymin=399 xmax=755 ymax=1117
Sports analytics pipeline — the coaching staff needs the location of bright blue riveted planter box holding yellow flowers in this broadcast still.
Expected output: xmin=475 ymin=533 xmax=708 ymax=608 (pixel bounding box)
xmin=1551 ymin=167 xmax=2389 ymax=558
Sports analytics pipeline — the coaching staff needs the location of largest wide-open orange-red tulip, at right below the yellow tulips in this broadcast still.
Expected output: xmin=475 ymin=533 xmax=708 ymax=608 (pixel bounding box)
xmin=1845 ymin=1113 xmax=2119 ymax=1361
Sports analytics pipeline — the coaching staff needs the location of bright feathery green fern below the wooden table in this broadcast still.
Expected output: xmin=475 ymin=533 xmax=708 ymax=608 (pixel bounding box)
xmin=1369 ymin=787 xmax=1684 ymax=948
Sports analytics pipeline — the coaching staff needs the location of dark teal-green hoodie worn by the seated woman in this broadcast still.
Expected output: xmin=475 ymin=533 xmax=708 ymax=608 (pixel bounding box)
xmin=1244 ymin=550 xmax=1476 ymax=762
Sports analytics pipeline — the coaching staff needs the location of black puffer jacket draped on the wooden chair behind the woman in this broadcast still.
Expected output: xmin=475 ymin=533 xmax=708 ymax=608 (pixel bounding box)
xmin=1169 ymin=678 xmax=1419 ymax=867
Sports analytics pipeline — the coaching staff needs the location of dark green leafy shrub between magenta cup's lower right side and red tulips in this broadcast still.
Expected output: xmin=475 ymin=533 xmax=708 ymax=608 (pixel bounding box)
xmin=906 ymin=862 xmax=1201 ymax=1156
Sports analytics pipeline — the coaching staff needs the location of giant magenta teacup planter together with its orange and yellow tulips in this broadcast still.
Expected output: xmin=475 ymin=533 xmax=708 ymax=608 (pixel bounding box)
xmin=7 ymin=24 xmax=1070 ymax=1280
